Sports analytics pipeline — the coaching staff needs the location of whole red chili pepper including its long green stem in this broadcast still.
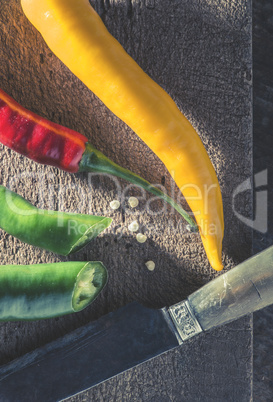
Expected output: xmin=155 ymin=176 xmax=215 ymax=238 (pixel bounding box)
xmin=0 ymin=89 xmax=198 ymax=232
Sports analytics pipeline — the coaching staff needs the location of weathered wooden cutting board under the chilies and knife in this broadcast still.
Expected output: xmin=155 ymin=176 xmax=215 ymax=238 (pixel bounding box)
xmin=0 ymin=0 xmax=252 ymax=401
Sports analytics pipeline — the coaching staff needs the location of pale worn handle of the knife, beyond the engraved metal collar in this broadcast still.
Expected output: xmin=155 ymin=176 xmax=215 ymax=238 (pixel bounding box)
xmin=188 ymin=246 xmax=273 ymax=331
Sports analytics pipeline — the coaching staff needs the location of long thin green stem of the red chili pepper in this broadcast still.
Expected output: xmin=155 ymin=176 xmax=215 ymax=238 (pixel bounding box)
xmin=79 ymin=142 xmax=198 ymax=232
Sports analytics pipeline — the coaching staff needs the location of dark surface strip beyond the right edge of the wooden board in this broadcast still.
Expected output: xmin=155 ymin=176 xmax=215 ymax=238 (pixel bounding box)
xmin=253 ymin=0 xmax=273 ymax=401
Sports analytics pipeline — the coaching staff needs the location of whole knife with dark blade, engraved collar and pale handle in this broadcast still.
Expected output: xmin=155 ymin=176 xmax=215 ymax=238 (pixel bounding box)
xmin=0 ymin=246 xmax=273 ymax=402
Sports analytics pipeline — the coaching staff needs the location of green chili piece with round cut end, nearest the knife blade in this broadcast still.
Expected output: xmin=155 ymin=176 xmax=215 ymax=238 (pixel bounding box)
xmin=0 ymin=261 xmax=107 ymax=321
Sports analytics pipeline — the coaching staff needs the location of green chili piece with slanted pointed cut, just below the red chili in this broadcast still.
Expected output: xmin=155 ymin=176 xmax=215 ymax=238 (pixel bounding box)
xmin=0 ymin=186 xmax=112 ymax=255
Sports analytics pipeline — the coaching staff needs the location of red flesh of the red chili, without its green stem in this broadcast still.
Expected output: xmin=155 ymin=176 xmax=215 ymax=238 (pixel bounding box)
xmin=0 ymin=89 xmax=88 ymax=172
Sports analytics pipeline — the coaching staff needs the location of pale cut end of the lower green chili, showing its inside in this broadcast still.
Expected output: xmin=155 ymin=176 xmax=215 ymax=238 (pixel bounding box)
xmin=72 ymin=262 xmax=108 ymax=312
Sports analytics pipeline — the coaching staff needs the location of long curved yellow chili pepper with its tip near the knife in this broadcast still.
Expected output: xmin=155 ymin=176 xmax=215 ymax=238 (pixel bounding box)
xmin=21 ymin=0 xmax=224 ymax=270
